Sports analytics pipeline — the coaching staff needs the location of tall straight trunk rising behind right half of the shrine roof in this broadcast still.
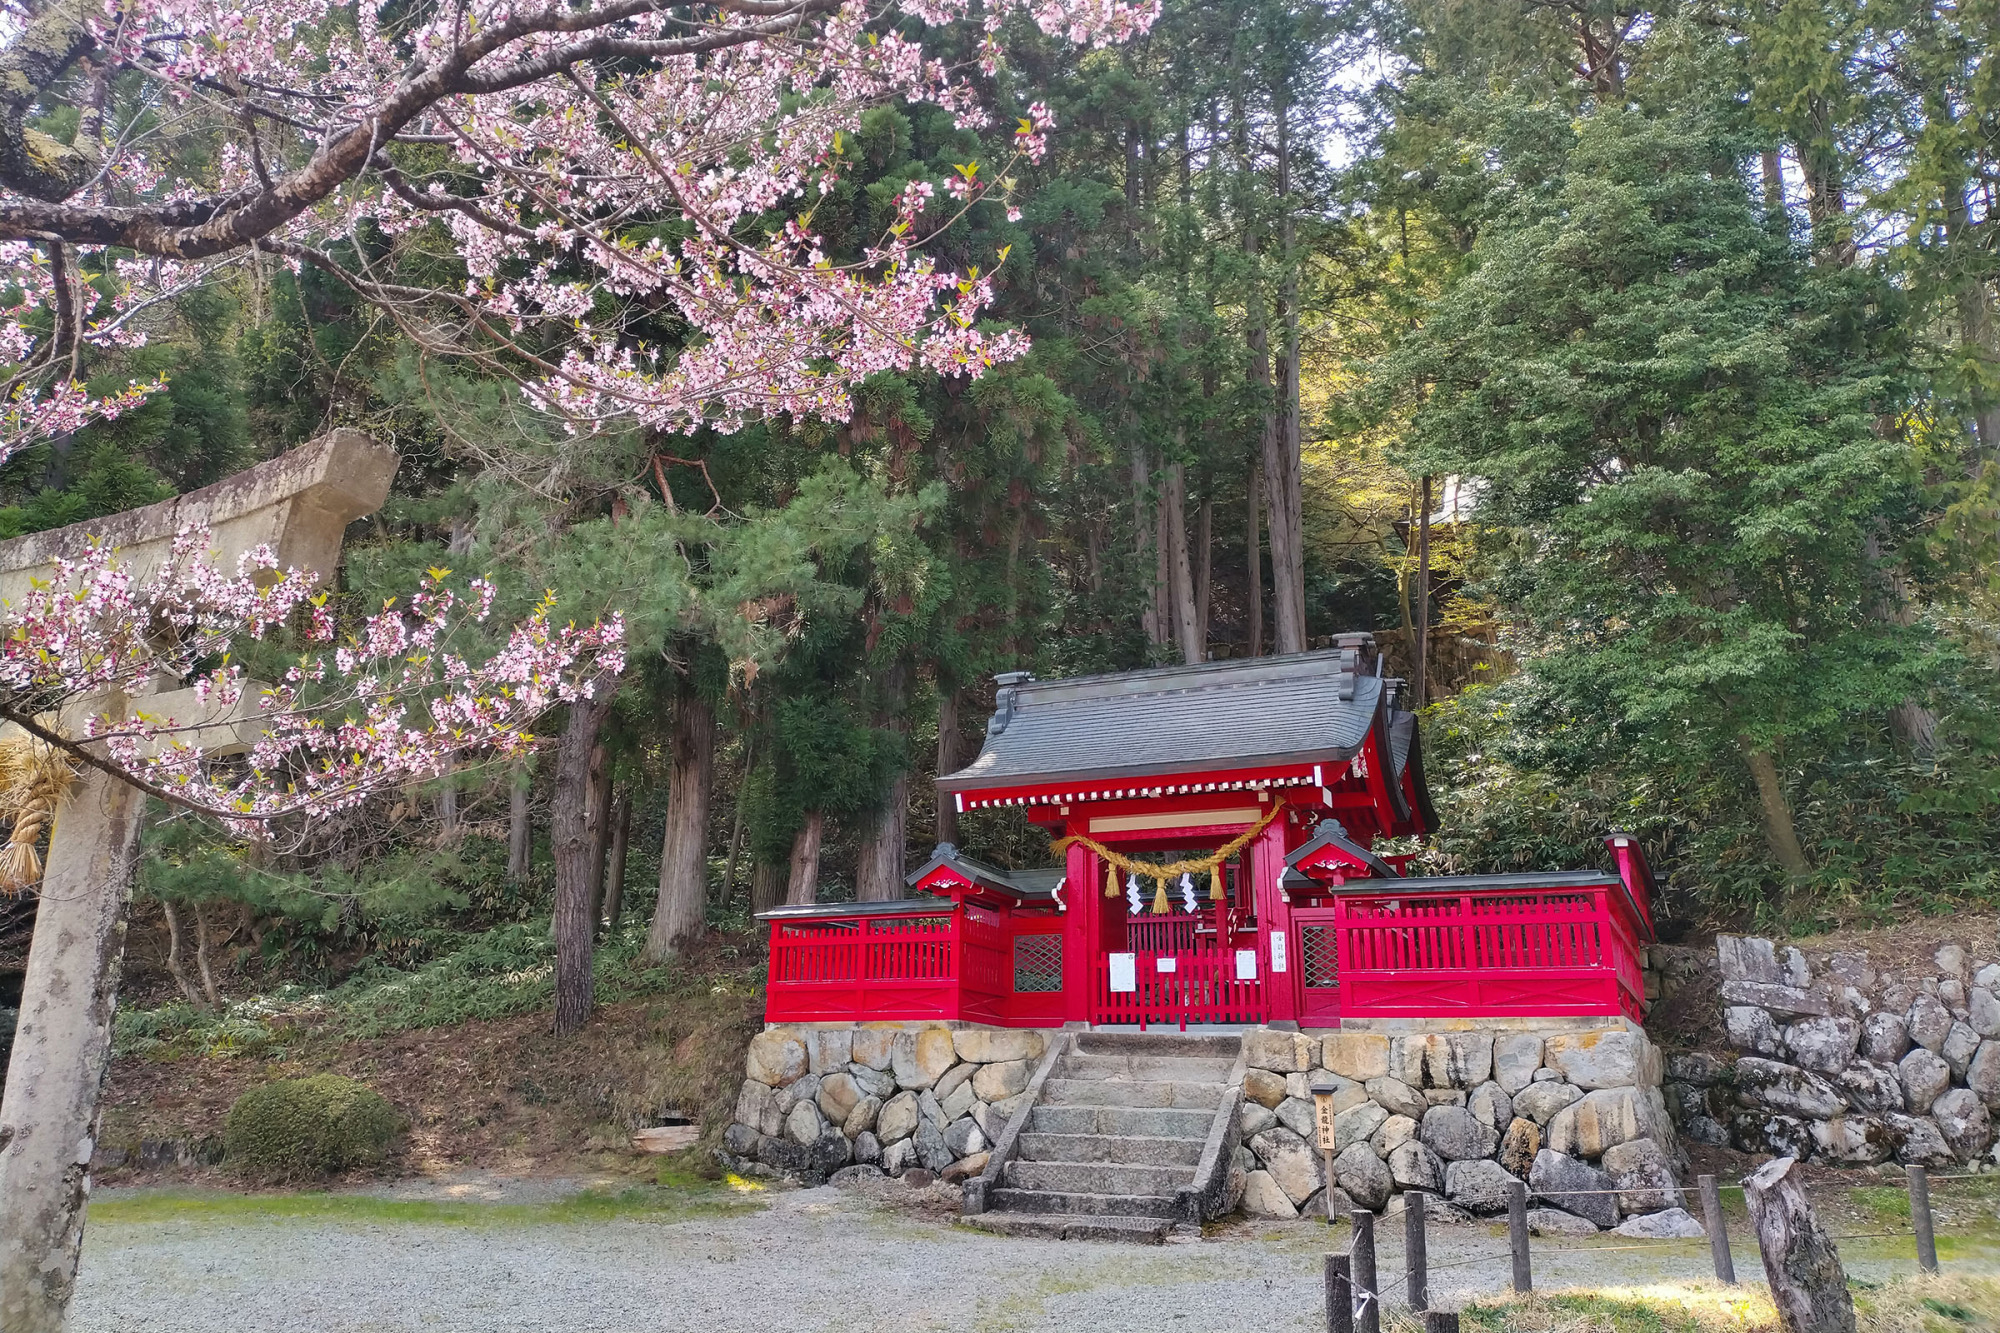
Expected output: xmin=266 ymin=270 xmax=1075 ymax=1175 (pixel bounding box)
xmin=1264 ymin=88 xmax=1306 ymax=652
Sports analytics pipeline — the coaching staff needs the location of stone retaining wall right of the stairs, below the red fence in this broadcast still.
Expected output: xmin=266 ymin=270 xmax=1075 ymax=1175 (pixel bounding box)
xmin=1236 ymin=1021 xmax=1698 ymax=1235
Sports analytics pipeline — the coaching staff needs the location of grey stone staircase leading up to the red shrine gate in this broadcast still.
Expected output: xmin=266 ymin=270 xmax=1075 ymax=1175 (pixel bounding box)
xmin=964 ymin=1033 xmax=1242 ymax=1245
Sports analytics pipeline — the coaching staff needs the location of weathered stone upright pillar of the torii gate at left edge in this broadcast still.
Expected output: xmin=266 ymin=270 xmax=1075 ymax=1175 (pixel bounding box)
xmin=0 ymin=769 xmax=146 ymax=1333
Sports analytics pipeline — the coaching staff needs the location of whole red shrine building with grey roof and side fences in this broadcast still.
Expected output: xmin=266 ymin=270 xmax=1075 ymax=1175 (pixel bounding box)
xmin=764 ymin=634 xmax=1652 ymax=1029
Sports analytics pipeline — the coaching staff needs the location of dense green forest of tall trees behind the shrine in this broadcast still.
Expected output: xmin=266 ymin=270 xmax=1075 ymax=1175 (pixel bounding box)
xmin=0 ymin=0 xmax=2000 ymax=1049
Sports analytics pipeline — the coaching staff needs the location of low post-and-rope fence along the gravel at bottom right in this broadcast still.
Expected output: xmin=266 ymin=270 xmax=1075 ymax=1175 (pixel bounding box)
xmin=1326 ymin=1167 xmax=1996 ymax=1333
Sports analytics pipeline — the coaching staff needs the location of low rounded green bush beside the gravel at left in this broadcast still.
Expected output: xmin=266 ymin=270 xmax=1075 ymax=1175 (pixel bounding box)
xmin=222 ymin=1075 xmax=402 ymax=1181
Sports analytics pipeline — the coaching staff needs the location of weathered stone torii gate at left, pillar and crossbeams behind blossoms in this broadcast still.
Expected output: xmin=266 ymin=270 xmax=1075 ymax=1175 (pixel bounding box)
xmin=0 ymin=430 xmax=396 ymax=1333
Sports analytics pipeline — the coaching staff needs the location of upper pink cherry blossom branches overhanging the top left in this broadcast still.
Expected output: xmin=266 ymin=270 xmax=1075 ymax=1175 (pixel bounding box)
xmin=0 ymin=0 xmax=1158 ymax=446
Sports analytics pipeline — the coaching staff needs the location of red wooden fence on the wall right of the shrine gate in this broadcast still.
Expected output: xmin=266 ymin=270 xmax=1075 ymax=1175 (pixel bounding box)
xmin=1292 ymin=883 xmax=1644 ymax=1025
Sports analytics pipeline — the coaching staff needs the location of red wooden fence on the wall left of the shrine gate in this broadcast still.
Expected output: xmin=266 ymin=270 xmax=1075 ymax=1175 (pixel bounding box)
xmin=764 ymin=901 xmax=1064 ymax=1027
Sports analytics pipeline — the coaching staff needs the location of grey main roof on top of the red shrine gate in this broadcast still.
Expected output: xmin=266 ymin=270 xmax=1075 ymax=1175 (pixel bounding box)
xmin=938 ymin=636 xmax=1408 ymax=791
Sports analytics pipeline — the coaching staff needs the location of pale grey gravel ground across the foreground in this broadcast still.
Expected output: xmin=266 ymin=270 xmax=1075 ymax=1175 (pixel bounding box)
xmin=70 ymin=1177 xmax=2000 ymax=1333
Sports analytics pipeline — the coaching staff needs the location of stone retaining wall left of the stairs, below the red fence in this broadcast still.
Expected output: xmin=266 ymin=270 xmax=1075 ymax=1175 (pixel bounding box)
xmin=722 ymin=1023 xmax=1048 ymax=1185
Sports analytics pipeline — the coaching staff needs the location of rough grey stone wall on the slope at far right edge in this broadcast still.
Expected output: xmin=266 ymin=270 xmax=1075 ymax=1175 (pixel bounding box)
xmin=1666 ymin=935 xmax=2000 ymax=1167
